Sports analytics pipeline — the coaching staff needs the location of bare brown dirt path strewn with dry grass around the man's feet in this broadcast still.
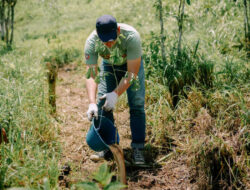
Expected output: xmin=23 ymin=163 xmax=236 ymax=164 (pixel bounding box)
xmin=56 ymin=63 xmax=197 ymax=190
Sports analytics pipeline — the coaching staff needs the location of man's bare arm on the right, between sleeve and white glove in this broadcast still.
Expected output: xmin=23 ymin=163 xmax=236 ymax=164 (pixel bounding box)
xmin=114 ymin=57 xmax=141 ymax=96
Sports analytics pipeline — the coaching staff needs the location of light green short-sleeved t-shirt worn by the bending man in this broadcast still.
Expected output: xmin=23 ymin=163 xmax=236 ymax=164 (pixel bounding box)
xmin=84 ymin=23 xmax=142 ymax=65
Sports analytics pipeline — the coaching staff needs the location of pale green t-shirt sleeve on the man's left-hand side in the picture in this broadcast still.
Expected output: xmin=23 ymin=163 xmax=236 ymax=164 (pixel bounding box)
xmin=84 ymin=33 xmax=98 ymax=65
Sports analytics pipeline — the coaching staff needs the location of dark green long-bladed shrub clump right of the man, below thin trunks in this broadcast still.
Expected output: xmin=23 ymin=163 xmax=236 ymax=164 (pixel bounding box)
xmin=164 ymin=43 xmax=214 ymax=107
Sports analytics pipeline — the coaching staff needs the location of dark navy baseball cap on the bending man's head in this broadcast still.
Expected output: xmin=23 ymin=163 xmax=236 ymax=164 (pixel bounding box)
xmin=96 ymin=15 xmax=117 ymax=42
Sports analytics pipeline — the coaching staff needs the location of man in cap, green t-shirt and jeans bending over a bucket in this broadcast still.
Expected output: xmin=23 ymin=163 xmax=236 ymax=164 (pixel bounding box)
xmin=85 ymin=15 xmax=146 ymax=165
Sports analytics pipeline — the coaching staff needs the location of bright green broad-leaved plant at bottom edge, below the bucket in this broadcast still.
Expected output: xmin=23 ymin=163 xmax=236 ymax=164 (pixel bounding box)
xmin=73 ymin=162 xmax=126 ymax=190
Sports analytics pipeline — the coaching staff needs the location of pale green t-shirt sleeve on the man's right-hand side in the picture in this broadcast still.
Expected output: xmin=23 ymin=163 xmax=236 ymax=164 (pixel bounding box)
xmin=127 ymin=32 xmax=142 ymax=60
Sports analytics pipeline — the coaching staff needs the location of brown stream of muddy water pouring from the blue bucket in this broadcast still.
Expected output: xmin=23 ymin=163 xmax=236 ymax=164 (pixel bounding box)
xmin=109 ymin=144 xmax=127 ymax=185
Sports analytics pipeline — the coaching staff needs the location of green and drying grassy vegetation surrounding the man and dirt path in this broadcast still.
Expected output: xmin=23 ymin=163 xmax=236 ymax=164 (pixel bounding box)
xmin=0 ymin=0 xmax=250 ymax=189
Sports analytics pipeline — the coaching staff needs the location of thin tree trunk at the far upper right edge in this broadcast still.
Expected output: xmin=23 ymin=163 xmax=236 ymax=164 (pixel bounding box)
xmin=243 ymin=0 xmax=250 ymax=58
